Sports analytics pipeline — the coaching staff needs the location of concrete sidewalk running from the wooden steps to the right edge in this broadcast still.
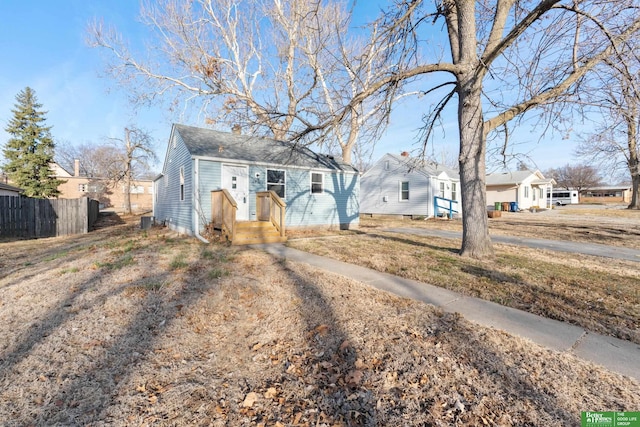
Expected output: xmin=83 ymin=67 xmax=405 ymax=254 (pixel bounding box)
xmin=252 ymin=244 xmax=640 ymax=379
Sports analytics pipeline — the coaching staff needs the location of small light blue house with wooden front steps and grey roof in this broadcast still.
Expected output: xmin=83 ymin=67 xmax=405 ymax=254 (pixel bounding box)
xmin=153 ymin=124 xmax=360 ymax=243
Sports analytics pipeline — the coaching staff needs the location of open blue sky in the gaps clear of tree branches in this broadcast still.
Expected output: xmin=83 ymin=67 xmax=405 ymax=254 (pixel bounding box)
xmin=0 ymin=0 xmax=575 ymax=174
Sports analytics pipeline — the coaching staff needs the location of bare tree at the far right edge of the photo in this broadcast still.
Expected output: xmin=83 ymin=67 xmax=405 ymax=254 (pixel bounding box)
xmin=577 ymin=49 xmax=640 ymax=209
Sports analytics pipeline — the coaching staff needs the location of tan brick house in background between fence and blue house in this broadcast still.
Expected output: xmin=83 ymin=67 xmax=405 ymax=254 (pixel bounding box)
xmin=50 ymin=159 xmax=153 ymax=212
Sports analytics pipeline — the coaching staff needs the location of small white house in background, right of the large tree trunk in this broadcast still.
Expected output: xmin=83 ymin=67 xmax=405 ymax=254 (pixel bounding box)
xmin=486 ymin=170 xmax=556 ymax=209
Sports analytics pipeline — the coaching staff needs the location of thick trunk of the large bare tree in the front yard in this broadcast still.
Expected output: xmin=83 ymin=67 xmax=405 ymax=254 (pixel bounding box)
xmin=458 ymin=73 xmax=494 ymax=259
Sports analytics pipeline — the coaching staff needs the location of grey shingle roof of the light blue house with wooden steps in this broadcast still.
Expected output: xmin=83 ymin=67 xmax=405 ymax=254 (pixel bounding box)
xmin=174 ymin=124 xmax=357 ymax=172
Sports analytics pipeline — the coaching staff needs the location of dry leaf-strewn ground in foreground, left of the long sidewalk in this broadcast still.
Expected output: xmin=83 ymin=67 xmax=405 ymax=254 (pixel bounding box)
xmin=0 ymin=212 xmax=640 ymax=426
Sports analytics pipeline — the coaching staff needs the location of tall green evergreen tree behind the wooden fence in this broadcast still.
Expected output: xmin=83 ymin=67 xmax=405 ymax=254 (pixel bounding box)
xmin=3 ymin=87 xmax=64 ymax=198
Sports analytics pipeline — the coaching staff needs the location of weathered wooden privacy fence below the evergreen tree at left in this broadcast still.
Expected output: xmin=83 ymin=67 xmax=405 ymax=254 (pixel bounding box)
xmin=0 ymin=196 xmax=99 ymax=237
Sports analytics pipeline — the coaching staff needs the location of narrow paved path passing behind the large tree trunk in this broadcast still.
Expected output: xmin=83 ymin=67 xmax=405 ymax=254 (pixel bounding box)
xmin=384 ymin=228 xmax=640 ymax=262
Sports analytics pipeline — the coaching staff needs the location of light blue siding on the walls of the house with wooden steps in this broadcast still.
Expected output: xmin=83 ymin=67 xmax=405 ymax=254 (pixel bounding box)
xmin=154 ymin=125 xmax=360 ymax=235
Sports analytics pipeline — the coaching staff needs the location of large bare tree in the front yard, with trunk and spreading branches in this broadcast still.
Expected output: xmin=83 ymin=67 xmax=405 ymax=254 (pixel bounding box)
xmin=356 ymin=0 xmax=640 ymax=258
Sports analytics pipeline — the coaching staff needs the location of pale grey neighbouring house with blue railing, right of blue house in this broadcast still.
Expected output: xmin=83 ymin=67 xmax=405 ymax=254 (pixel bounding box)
xmin=360 ymin=152 xmax=462 ymax=217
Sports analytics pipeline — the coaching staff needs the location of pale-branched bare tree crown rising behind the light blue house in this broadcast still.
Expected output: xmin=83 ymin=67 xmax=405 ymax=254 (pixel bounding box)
xmin=89 ymin=0 xmax=400 ymax=162
